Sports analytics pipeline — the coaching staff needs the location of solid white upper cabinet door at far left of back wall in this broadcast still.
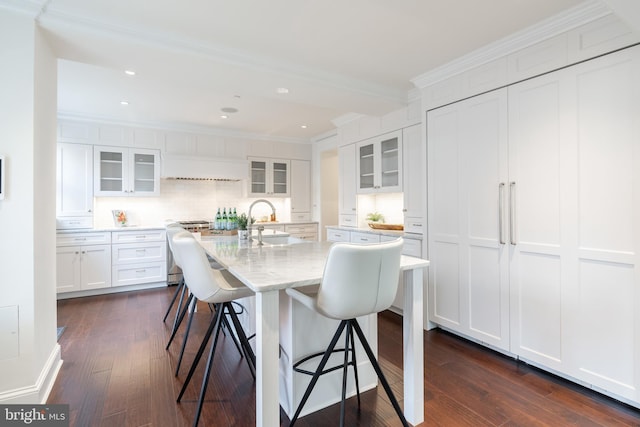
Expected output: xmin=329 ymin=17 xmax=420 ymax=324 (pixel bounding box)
xmin=56 ymin=143 xmax=93 ymax=217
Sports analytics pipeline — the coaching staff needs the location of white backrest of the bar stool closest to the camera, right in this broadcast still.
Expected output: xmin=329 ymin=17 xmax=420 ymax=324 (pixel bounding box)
xmin=316 ymin=239 xmax=404 ymax=320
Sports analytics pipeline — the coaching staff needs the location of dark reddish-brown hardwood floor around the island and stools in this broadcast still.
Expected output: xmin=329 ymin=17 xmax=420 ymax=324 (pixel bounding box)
xmin=48 ymin=288 xmax=640 ymax=427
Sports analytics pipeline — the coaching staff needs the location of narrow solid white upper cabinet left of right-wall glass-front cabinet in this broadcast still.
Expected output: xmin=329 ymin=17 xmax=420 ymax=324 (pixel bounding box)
xmin=338 ymin=144 xmax=358 ymax=227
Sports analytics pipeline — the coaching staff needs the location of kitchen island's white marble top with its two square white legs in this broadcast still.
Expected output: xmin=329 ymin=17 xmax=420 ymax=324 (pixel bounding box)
xmin=201 ymin=237 xmax=429 ymax=427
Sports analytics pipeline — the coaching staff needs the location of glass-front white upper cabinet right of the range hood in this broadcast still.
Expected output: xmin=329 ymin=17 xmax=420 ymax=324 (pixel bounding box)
xmin=248 ymin=157 xmax=291 ymax=197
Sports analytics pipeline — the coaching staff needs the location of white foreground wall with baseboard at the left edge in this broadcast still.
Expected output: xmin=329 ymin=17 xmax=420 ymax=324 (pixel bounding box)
xmin=0 ymin=9 xmax=60 ymax=403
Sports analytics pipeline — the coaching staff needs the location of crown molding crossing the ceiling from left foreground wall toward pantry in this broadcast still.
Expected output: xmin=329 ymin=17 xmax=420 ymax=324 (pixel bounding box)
xmin=38 ymin=7 xmax=406 ymax=103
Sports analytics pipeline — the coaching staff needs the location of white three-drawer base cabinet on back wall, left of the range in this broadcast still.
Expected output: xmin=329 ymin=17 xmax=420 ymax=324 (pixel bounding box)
xmin=112 ymin=230 xmax=167 ymax=286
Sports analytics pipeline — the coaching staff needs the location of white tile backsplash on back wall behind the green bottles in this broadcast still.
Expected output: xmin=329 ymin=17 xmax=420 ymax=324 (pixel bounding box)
xmin=94 ymin=179 xmax=291 ymax=228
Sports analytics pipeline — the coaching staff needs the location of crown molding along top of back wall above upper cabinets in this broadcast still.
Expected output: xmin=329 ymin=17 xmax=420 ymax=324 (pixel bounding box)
xmin=58 ymin=111 xmax=312 ymax=144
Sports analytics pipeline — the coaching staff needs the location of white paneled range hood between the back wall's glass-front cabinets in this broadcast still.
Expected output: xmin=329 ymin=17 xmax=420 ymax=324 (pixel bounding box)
xmin=160 ymin=154 xmax=249 ymax=181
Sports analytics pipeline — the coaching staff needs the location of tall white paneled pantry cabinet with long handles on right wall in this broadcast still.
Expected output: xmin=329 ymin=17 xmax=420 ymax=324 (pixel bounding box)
xmin=427 ymin=47 xmax=640 ymax=404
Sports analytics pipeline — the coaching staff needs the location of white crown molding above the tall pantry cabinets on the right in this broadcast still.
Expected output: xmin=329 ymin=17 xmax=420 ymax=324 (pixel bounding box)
xmin=411 ymin=0 xmax=612 ymax=89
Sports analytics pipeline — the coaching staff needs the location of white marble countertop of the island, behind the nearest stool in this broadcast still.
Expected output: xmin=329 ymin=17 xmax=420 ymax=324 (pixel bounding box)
xmin=200 ymin=237 xmax=429 ymax=292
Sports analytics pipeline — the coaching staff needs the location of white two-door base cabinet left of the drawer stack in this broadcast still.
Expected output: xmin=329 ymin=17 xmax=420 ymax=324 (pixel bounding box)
xmin=56 ymin=232 xmax=111 ymax=293
